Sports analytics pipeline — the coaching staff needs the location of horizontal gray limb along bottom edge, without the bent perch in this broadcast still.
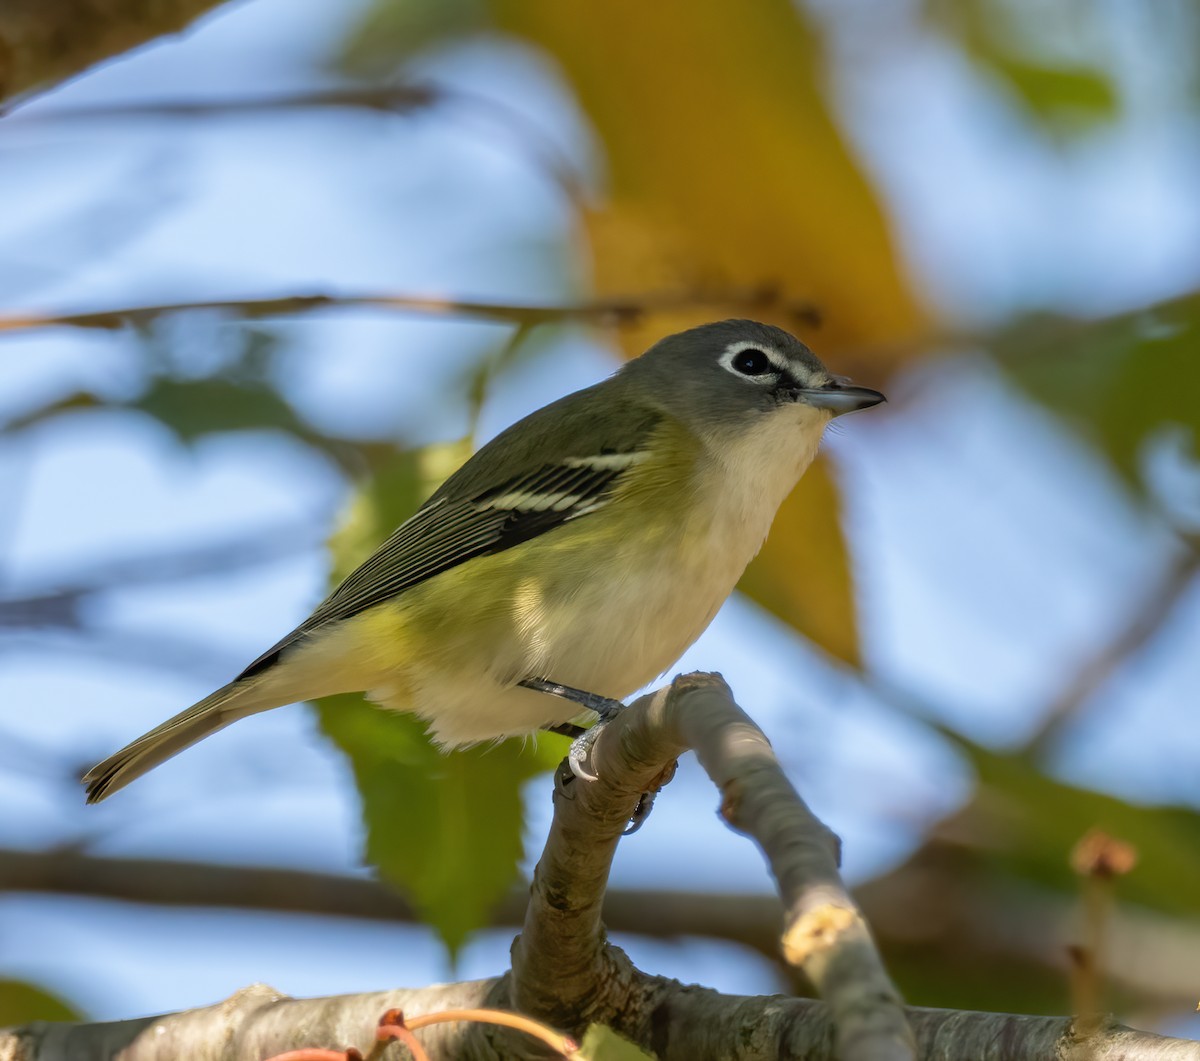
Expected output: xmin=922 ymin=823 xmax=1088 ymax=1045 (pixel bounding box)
xmin=7 ymin=979 xmax=1200 ymax=1061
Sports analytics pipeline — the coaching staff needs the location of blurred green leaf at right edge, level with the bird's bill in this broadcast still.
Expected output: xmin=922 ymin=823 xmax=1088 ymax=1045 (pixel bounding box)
xmin=995 ymin=294 xmax=1200 ymax=490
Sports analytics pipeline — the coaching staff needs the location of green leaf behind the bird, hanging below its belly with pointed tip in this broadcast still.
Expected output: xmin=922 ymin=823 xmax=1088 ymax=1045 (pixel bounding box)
xmin=317 ymin=443 xmax=565 ymax=952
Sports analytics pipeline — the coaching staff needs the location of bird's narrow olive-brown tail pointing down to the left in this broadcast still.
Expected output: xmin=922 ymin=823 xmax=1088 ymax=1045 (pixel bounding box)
xmin=83 ymin=679 xmax=280 ymax=803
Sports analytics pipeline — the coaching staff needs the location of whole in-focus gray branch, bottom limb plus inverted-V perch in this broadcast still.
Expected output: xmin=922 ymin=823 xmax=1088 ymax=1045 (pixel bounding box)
xmin=0 ymin=675 xmax=1200 ymax=1061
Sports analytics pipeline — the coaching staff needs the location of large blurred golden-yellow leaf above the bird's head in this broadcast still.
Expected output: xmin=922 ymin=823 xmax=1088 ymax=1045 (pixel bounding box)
xmin=492 ymin=0 xmax=920 ymax=353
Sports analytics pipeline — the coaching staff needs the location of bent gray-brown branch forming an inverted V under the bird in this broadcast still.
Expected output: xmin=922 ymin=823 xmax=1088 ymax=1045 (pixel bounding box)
xmin=511 ymin=673 xmax=914 ymax=1061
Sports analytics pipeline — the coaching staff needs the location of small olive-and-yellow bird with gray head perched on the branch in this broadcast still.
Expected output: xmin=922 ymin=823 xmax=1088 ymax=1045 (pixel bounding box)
xmin=83 ymin=319 xmax=886 ymax=803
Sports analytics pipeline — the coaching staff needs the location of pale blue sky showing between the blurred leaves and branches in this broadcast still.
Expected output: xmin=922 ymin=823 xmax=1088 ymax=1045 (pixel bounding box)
xmin=0 ymin=0 xmax=1200 ymax=1032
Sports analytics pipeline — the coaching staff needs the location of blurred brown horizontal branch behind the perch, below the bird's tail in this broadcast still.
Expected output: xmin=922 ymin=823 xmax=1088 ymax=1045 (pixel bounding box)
xmin=9 ymin=840 xmax=1200 ymax=1009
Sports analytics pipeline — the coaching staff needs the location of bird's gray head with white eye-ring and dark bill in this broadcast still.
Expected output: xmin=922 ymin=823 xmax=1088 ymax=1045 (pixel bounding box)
xmin=622 ymin=320 xmax=884 ymax=433
